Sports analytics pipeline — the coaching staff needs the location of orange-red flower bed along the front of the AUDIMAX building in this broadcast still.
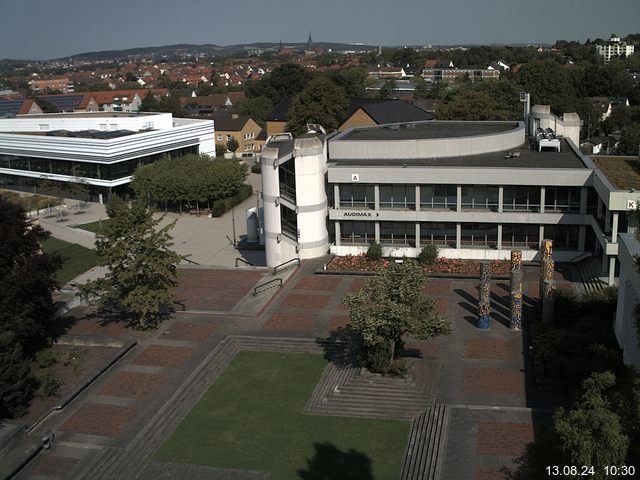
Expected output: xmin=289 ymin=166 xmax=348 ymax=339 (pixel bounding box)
xmin=327 ymin=254 xmax=511 ymax=277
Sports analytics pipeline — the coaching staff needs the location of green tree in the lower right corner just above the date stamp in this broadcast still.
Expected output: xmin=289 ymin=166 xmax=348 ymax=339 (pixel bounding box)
xmin=554 ymin=372 xmax=629 ymax=472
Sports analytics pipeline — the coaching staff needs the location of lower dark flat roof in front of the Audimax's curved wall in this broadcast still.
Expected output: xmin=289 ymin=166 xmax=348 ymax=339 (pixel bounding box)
xmin=328 ymin=138 xmax=587 ymax=169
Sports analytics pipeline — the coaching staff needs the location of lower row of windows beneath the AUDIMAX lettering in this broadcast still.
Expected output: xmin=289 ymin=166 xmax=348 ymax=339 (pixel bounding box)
xmin=340 ymin=221 xmax=579 ymax=250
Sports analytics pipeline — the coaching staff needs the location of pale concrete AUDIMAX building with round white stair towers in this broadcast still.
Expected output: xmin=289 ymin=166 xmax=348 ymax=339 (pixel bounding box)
xmin=261 ymin=106 xmax=640 ymax=283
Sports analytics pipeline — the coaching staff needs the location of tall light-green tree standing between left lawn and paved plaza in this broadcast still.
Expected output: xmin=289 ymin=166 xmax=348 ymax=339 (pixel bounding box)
xmin=81 ymin=198 xmax=185 ymax=328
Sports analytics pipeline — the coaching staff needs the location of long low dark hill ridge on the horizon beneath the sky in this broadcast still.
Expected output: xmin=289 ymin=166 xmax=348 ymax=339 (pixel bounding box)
xmin=60 ymin=42 xmax=377 ymax=61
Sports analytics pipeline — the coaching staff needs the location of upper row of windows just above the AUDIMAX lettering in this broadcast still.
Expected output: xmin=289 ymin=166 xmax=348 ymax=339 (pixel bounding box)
xmin=339 ymin=184 xmax=580 ymax=212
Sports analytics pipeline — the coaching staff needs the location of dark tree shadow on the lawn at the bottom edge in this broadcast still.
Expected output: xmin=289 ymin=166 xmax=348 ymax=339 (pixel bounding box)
xmin=298 ymin=442 xmax=374 ymax=480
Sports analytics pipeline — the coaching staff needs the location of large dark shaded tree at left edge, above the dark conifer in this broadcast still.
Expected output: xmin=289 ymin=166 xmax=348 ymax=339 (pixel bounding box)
xmin=0 ymin=196 xmax=61 ymax=353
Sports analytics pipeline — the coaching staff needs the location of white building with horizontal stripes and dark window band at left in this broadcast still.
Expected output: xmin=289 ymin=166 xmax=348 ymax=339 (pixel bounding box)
xmin=0 ymin=112 xmax=215 ymax=200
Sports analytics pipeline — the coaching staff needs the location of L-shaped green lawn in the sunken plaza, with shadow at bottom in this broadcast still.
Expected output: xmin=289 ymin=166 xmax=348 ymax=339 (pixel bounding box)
xmin=155 ymin=351 xmax=410 ymax=480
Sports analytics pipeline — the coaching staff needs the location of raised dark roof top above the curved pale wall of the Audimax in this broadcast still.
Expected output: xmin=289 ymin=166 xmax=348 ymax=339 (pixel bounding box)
xmin=340 ymin=120 xmax=519 ymax=141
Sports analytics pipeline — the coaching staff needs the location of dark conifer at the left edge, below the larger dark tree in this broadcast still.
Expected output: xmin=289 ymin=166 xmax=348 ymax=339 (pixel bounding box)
xmin=0 ymin=332 xmax=36 ymax=418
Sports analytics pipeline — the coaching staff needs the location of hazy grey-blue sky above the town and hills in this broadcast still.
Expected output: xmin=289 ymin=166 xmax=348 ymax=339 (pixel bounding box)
xmin=0 ymin=0 xmax=640 ymax=59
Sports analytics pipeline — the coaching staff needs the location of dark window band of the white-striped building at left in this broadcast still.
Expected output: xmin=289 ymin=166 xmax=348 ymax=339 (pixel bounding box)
xmin=0 ymin=146 xmax=198 ymax=180
